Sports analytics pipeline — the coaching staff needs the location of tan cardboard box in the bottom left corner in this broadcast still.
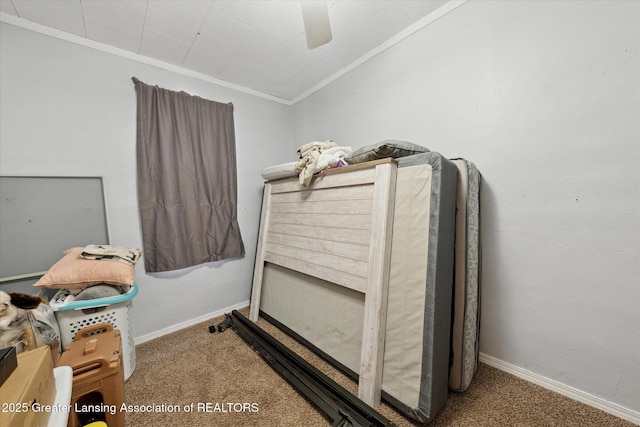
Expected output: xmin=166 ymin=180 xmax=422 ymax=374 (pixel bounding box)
xmin=0 ymin=346 xmax=56 ymax=427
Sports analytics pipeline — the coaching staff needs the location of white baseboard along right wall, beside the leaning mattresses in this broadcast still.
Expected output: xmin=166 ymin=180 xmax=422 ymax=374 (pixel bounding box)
xmin=479 ymin=353 xmax=640 ymax=426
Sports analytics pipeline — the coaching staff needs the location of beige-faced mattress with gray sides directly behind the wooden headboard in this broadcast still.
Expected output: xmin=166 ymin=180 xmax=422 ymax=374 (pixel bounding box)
xmin=260 ymin=152 xmax=457 ymax=422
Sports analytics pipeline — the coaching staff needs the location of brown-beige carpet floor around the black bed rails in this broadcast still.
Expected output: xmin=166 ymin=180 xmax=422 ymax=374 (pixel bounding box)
xmin=125 ymin=310 xmax=632 ymax=427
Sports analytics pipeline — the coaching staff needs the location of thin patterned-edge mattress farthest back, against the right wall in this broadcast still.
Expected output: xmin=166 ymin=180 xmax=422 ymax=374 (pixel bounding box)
xmin=449 ymin=159 xmax=481 ymax=391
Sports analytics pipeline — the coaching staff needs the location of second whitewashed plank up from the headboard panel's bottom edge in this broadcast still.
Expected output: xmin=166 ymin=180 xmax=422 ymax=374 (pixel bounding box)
xmin=265 ymin=242 xmax=368 ymax=277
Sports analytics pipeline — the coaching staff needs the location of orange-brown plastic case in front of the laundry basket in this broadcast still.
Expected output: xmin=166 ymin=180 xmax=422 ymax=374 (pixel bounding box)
xmin=58 ymin=323 xmax=124 ymax=427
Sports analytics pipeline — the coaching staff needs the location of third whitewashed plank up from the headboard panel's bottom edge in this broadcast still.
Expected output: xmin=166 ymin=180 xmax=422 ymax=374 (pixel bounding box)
xmin=267 ymin=230 xmax=369 ymax=262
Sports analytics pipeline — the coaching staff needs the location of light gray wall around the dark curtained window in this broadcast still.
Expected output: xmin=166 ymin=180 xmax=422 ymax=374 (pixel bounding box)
xmin=0 ymin=23 xmax=295 ymax=336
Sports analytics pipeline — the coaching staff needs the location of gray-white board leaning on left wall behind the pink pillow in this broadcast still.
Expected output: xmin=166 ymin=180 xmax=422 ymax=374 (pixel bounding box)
xmin=0 ymin=176 xmax=109 ymax=282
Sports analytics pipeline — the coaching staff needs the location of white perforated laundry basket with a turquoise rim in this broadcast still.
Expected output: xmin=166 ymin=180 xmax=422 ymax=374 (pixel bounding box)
xmin=50 ymin=283 xmax=138 ymax=381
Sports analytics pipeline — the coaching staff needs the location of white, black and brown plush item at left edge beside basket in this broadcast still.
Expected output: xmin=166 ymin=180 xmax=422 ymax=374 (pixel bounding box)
xmin=0 ymin=291 xmax=43 ymax=353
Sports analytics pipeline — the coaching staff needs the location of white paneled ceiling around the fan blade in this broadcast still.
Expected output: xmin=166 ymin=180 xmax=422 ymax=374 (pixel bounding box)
xmin=0 ymin=0 xmax=458 ymax=102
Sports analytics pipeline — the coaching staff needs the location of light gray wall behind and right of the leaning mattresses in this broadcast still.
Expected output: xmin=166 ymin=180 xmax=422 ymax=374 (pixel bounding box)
xmin=294 ymin=1 xmax=640 ymax=411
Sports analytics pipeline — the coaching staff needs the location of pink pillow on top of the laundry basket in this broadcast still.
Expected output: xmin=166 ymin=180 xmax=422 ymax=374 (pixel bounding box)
xmin=33 ymin=248 xmax=135 ymax=289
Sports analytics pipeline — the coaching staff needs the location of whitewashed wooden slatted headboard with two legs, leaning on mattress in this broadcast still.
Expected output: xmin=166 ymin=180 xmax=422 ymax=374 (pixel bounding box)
xmin=249 ymin=159 xmax=397 ymax=407
